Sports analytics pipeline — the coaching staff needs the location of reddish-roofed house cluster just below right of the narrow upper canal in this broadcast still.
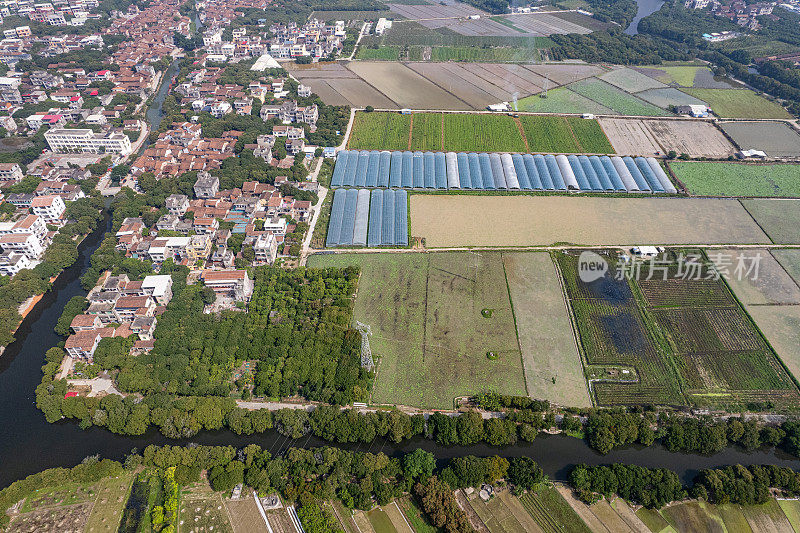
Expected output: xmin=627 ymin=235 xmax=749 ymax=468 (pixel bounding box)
xmin=131 ymin=122 xmax=242 ymax=176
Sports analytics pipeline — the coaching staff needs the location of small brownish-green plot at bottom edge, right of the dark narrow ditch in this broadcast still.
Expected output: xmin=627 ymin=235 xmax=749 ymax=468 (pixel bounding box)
xmin=178 ymin=483 xmax=233 ymax=533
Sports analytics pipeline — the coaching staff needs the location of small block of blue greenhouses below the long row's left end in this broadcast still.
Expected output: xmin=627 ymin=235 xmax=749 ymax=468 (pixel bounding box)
xmin=325 ymin=189 xmax=408 ymax=247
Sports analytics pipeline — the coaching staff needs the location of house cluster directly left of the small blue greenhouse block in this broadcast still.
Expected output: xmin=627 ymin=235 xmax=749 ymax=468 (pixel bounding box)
xmin=116 ymin=177 xmax=311 ymax=268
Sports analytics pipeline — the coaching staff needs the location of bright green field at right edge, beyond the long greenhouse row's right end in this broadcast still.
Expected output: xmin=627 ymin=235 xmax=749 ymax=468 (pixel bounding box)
xmin=669 ymin=161 xmax=800 ymax=197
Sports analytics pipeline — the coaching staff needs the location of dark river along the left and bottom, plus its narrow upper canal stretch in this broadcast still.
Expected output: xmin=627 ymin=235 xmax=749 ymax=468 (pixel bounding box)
xmin=0 ymin=39 xmax=800 ymax=487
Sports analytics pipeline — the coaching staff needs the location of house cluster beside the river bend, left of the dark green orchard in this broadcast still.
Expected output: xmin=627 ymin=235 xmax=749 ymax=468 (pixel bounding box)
xmin=64 ymin=274 xmax=172 ymax=362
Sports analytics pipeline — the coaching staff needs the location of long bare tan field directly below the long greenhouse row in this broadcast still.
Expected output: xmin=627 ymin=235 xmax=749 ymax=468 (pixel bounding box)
xmin=409 ymin=194 xmax=769 ymax=248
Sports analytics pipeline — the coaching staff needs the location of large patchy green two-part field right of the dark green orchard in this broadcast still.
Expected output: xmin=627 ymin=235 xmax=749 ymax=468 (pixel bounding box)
xmin=309 ymin=252 xmax=525 ymax=409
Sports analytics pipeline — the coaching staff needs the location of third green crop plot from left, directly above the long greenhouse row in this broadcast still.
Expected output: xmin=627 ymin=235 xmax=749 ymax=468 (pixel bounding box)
xmin=442 ymin=113 xmax=526 ymax=152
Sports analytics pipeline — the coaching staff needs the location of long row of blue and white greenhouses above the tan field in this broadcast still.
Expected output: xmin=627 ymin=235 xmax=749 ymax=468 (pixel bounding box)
xmin=331 ymin=150 xmax=677 ymax=193
